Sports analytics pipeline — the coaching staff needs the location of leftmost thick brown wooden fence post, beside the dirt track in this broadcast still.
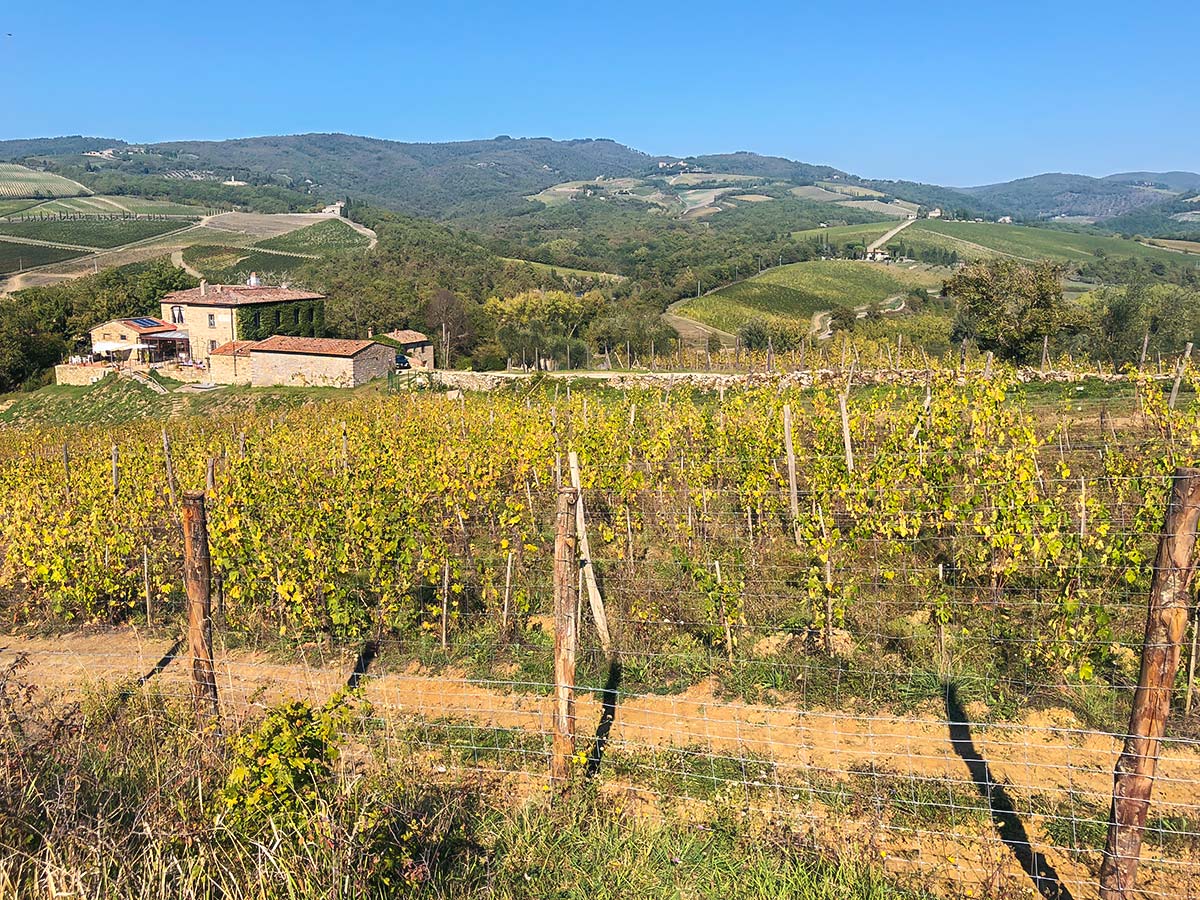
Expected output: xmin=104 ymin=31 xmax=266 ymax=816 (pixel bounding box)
xmin=184 ymin=491 xmax=221 ymax=728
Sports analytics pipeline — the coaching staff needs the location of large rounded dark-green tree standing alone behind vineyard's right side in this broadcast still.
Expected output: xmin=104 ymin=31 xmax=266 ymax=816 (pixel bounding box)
xmin=946 ymin=259 xmax=1076 ymax=364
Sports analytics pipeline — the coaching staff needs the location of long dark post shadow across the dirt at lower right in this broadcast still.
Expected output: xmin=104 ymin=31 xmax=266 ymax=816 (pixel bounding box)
xmin=943 ymin=682 xmax=1073 ymax=900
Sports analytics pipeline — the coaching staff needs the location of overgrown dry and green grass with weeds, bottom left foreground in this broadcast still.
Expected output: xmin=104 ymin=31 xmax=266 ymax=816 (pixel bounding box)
xmin=0 ymin=666 xmax=917 ymax=900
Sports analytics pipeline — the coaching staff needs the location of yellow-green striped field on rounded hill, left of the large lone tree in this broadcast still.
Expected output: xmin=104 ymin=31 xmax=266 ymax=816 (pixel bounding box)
xmin=673 ymin=259 xmax=941 ymax=332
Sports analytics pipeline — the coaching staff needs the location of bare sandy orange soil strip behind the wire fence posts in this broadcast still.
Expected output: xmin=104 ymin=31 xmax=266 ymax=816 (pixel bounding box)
xmin=0 ymin=629 xmax=1200 ymax=900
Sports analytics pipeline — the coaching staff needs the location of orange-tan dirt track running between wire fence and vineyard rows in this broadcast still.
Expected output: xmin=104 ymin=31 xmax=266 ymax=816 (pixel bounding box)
xmin=0 ymin=629 xmax=1200 ymax=900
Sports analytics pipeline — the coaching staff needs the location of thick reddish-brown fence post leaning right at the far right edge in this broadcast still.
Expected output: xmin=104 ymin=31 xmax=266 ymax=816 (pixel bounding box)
xmin=1100 ymin=467 xmax=1200 ymax=900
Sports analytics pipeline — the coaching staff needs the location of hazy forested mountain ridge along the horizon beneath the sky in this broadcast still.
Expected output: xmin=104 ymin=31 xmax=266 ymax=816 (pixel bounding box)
xmin=0 ymin=134 xmax=1200 ymax=234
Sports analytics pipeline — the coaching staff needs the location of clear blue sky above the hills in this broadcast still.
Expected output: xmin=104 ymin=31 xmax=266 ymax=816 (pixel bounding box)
xmin=0 ymin=0 xmax=1200 ymax=185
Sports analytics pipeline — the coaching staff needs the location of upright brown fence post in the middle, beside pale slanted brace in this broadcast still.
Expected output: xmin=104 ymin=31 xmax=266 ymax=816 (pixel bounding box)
xmin=550 ymin=487 xmax=580 ymax=786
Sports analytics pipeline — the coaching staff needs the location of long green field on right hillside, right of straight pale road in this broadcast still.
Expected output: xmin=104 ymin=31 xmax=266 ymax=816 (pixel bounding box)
xmin=896 ymin=218 xmax=1182 ymax=263
